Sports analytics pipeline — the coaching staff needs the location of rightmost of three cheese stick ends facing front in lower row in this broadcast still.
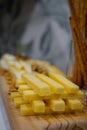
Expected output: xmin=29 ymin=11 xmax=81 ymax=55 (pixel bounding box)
xmin=67 ymin=99 xmax=83 ymax=110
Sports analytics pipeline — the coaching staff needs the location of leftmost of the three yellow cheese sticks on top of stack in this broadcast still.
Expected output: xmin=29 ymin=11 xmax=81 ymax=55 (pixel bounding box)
xmin=22 ymin=74 xmax=51 ymax=96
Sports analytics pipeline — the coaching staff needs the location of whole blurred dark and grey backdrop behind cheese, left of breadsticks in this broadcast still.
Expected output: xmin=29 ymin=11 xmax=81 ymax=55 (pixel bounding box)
xmin=0 ymin=0 xmax=72 ymax=73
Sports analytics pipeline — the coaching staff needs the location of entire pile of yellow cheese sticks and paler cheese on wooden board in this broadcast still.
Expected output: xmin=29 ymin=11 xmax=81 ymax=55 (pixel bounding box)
xmin=1 ymin=55 xmax=84 ymax=116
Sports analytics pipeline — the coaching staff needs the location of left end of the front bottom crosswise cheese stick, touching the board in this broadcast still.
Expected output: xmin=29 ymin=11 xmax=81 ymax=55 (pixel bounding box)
xmin=20 ymin=104 xmax=34 ymax=116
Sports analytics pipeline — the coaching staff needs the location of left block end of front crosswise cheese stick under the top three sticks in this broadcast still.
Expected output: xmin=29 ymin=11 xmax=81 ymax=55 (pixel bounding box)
xmin=23 ymin=90 xmax=40 ymax=102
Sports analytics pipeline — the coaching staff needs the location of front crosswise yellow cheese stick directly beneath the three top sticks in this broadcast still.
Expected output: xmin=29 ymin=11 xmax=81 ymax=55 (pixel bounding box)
xmin=23 ymin=90 xmax=84 ymax=101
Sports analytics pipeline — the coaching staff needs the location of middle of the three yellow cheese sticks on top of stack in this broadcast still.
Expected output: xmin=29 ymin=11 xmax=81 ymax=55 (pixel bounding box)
xmin=36 ymin=73 xmax=64 ymax=94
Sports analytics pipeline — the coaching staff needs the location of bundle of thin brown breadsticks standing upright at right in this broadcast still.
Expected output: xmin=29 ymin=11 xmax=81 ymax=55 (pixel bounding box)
xmin=69 ymin=0 xmax=87 ymax=88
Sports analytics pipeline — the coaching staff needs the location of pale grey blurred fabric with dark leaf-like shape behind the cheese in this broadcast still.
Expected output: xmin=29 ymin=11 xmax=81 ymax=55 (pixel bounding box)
xmin=21 ymin=0 xmax=71 ymax=72
